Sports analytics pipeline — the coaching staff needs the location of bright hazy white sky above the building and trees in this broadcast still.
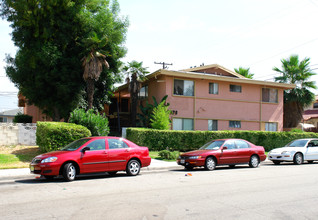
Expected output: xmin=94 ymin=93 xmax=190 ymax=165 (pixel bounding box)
xmin=0 ymin=0 xmax=318 ymax=111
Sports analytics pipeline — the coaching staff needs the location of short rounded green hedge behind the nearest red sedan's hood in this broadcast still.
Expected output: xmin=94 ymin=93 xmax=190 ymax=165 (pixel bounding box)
xmin=36 ymin=121 xmax=91 ymax=152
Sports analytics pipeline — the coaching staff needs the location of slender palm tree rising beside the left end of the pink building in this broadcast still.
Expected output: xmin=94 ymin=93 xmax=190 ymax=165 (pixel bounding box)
xmin=123 ymin=60 xmax=149 ymax=127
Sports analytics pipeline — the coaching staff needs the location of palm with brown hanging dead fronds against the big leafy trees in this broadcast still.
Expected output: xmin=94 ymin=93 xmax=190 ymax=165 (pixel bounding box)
xmin=82 ymin=32 xmax=109 ymax=109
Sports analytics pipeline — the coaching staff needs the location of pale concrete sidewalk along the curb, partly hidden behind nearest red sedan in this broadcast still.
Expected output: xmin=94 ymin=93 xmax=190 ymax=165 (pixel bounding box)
xmin=0 ymin=159 xmax=179 ymax=179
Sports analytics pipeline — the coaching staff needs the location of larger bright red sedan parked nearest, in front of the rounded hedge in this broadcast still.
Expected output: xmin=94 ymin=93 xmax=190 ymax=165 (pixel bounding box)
xmin=30 ymin=137 xmax=151 ymax=181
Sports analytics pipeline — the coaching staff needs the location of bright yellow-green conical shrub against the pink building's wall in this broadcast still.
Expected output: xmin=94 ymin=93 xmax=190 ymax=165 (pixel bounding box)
xmin=150 ymin=102 xmax=171 ymax=130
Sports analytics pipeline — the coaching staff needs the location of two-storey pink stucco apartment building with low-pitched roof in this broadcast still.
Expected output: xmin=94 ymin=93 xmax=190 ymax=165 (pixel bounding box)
xmin=109 ymin=64 xmax=295 ymax=131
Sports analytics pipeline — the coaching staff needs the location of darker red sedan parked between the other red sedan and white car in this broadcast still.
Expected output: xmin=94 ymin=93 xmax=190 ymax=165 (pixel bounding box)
xmin=177 ymin=139 xmax=266 ymax=170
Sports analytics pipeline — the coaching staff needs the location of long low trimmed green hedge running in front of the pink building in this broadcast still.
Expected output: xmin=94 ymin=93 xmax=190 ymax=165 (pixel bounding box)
xmin=126 ymin=128 xmax=318 ymax=151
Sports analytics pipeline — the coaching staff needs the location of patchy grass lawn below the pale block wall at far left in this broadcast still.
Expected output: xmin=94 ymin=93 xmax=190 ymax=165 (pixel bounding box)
xmin=0 ymin=145 xmax=41 ymax=169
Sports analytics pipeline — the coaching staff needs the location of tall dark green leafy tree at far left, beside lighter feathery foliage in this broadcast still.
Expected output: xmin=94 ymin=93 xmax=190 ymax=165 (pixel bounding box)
xmin=1 ymin=0 xmax=84 ymax=121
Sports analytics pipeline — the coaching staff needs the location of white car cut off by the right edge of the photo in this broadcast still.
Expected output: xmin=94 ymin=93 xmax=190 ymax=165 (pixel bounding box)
xmin=267 ymin=138 xmax=318 ymax=165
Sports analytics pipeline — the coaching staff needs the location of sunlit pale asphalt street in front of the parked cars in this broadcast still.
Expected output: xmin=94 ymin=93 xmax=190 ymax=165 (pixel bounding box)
xmin=0 ymin=162 xmax=318 ymax=220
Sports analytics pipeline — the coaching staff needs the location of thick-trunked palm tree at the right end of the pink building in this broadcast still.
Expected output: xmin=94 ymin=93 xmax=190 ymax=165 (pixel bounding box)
xmin=273 ymin=55 xmax=317 ymax=128
